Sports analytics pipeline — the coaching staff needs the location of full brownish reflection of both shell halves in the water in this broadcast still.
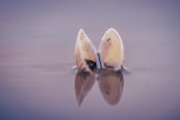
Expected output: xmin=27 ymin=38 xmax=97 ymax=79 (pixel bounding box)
xmin=75 ymin=69 xmax=124 ymax=106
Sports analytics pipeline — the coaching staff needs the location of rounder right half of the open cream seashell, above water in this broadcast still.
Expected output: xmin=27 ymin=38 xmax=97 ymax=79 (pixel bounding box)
xmin=99 ymin=28 xmax=124 ymax=70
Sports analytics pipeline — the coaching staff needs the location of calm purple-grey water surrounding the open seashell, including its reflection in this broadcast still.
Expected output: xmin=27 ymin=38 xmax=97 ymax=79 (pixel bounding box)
xmin=0 ymin=0 xmax=180 ymax=120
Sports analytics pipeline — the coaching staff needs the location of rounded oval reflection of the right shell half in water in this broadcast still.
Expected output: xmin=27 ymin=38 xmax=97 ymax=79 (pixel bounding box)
xmin=98 ymin=70 xmax=124 ymax=105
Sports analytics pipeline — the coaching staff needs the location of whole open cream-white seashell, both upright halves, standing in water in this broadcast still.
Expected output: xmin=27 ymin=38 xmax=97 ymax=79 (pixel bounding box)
xmin=75 ymin=28 xmax=124 ymax=72
